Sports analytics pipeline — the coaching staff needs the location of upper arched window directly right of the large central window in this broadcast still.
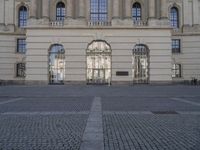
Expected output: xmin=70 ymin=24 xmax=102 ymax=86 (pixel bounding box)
xmin=132 ymin=2 xmax=142 ymax=21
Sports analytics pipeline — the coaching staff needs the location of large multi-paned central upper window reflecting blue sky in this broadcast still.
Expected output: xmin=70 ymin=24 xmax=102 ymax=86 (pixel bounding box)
xmin=90 ymin=0 xmax=108 ymax=22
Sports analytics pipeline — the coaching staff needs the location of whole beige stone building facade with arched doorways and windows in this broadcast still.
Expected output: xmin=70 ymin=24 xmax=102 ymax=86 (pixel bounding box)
xmin=0 ymin=0 xmax=200 ymax=84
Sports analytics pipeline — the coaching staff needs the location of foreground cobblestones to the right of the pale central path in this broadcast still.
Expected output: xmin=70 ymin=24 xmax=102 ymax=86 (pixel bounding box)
xmin=103 ymin=114 xmax=200 ymax=150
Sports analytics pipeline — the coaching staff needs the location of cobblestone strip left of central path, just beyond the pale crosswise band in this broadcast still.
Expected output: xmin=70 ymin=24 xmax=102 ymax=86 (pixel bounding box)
xmin=0 ymin=97 xmax=92 ymax=112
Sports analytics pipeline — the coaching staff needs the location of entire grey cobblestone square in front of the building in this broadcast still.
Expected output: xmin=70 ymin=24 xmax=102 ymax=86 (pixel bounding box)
xmin=0 ymin=85 xmax=200 ymax=150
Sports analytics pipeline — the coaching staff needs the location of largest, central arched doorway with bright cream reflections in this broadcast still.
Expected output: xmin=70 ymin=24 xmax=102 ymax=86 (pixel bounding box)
xmin=86 ymin=40 xmax=111 ymax=84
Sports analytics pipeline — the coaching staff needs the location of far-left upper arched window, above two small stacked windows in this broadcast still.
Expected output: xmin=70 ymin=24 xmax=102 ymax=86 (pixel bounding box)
xmin=18 ymin=6 xmax=28 ymax=27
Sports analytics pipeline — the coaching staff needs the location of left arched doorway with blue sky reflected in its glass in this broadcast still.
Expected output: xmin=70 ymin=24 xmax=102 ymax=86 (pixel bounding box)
xmin=49 ymin=44 xmax=65 ymax=84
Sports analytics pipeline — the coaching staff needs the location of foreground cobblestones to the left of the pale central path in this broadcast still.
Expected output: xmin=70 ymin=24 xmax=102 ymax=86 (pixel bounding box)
xmin=0 ymin=115 xmax=87 ymax=150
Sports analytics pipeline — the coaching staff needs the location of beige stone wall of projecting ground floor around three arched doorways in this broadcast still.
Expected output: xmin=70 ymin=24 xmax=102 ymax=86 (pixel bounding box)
xmin=26 ymin=29 xmax=171 ymax=82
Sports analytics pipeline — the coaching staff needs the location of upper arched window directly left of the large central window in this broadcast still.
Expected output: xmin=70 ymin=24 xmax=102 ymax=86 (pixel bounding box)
xmin=56 ymin=2 xmax=65 ymax=21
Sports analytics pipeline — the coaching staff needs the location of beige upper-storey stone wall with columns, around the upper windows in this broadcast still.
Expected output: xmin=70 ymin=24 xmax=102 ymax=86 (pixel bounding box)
xmin=0 ymin=0 xmax=200 ymax=25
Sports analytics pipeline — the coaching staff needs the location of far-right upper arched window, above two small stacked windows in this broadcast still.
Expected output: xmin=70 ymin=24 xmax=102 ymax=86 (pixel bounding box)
xmin=170 ymin=7 xmax=179 ymax=28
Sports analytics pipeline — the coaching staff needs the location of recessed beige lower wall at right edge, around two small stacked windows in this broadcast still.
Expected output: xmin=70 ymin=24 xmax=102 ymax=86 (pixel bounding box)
xmin=172 ymin=35 xmax=200 ymax=80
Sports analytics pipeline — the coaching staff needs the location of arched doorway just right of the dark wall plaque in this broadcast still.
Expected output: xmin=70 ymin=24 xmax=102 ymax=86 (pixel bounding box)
xmin=132 ymin=44 xmax=149 ymax=83
